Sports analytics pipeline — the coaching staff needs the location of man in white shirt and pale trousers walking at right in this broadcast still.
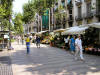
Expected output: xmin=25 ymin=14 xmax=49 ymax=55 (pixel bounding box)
xmin=75 ymin=35 xmax=84 ymax=60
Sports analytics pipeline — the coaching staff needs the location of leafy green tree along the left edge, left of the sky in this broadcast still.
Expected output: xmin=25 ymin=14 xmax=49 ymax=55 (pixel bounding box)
xmin=0 ymin=0 xmax=13 ymax=30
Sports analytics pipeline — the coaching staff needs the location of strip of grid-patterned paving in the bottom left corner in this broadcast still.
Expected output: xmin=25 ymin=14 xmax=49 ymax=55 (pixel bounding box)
xmin=0 ymin=50 xmax=13 ymax=75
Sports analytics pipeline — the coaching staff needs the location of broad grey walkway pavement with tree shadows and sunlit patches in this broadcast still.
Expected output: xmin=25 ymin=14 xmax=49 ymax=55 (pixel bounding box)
xmin=9 ymin=43 xmax=100 ymax=75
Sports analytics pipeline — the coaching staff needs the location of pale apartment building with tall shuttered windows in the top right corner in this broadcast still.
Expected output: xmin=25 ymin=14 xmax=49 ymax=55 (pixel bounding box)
xmin=73 ymin=0 xmax=100 ymax=25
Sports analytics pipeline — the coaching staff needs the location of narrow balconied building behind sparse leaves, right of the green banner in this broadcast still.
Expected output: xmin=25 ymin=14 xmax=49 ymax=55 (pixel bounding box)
xmin=51 ymin=0 xmax=67 ymax=30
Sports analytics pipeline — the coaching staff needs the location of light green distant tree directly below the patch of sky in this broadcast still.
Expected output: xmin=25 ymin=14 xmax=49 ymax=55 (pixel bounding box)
xmin=14 ymin=13 xmax=23 ymax=34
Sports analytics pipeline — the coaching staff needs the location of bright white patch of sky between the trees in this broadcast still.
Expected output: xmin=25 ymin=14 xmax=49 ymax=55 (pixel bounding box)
xmin=13 ymin=0 xmax=28 ymax=13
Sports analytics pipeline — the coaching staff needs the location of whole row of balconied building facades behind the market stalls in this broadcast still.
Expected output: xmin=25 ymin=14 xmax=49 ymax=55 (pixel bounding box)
xmin=24 ymin=0 xmax=100 ymax=32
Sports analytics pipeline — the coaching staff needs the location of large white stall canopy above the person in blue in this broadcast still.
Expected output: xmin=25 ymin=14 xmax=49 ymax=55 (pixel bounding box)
xmin=62 ymin=25 xmax=89 ymax=35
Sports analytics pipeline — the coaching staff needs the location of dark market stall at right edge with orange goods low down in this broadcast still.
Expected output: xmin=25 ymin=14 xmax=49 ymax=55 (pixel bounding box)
xmin=85 ymin=23 xmax=100 ymax=55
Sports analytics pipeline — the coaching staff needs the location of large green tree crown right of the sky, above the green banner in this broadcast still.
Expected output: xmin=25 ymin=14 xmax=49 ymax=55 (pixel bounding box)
xmin=23 ymin=0 xmax=57 ymax=23
